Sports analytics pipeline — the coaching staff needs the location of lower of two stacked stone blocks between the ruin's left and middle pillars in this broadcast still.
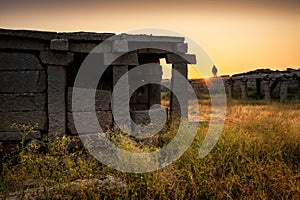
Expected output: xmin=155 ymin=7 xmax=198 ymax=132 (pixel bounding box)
xmin=67 ymin=111 xmax=113 ymax=134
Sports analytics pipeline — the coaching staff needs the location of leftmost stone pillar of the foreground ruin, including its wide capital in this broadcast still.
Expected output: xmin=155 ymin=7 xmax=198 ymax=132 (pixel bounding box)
xmin=40 ymin=51 xmax=73 ymax=139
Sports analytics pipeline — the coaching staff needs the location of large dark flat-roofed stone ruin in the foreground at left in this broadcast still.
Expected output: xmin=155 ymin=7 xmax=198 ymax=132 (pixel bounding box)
xmin=0 ymin=29 xmax=196 ymax=141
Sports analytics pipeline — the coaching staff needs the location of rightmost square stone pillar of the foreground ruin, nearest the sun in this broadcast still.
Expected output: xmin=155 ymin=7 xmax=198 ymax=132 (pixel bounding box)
xmin=170 ymin=63 xmax=188 ymax=119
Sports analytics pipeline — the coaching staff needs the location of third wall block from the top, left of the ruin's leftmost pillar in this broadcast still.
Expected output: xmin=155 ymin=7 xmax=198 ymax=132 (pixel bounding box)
xmin=0 ymin=93 xmax=46 ymax=112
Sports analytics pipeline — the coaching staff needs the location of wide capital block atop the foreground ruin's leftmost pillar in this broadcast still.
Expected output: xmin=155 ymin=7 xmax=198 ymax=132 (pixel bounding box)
xmin=40 ymin=51 xmax=73 ymax=66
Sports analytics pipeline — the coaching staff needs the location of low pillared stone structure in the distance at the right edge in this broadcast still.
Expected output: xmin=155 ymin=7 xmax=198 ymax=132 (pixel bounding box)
xmin=224 ymin=68 xmax=300 ymax=102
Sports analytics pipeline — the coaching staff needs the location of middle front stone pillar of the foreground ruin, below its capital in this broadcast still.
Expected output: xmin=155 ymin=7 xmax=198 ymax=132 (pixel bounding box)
xmin=112 ymin=65 xmax=131 ymax=131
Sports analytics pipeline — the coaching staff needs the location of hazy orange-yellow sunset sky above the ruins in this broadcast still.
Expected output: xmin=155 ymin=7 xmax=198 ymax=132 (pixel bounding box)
xmin=0 ymin=0 xmax=300 ymax=77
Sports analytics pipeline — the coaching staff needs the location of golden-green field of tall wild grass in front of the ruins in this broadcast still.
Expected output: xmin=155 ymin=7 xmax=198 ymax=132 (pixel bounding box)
xmin=0 ymin=100 xmax=300 ymax=199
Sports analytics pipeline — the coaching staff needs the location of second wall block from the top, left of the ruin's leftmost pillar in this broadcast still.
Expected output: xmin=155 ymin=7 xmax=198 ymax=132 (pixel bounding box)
xmin=0 ymin=71 xmax=46 ymax=93
